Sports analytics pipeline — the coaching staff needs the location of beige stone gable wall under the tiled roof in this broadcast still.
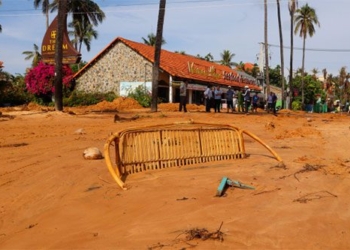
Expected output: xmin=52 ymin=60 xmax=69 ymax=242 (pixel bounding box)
xmin=76 ymin=42 xmax=152 ymax=95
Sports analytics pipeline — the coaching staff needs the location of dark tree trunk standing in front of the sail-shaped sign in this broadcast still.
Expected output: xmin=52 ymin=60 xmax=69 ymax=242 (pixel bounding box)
xmin=55 ymin=0 xmax=67 ymax=111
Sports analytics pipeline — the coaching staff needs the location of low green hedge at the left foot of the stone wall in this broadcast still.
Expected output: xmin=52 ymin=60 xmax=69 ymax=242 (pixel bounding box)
xmin=63 ymin=91 xmax=117 ymax=107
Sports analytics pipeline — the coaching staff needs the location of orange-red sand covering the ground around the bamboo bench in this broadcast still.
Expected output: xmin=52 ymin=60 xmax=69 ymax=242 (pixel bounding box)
xmin=0 ymin=98 xmax=350 ymax=250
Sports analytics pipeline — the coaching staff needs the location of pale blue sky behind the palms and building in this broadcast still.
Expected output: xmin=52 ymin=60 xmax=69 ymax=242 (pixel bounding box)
xmin=0 ymin=0 xmax=350 ymax=78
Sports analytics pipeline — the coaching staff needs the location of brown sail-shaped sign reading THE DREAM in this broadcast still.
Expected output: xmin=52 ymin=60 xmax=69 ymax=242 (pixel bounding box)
xmin=41 ymin=15 xmax=81 ymax=64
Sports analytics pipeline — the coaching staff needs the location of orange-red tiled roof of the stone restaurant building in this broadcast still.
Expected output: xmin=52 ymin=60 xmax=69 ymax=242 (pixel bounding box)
xmin=74 ymin=37 xmax=261 ymax=90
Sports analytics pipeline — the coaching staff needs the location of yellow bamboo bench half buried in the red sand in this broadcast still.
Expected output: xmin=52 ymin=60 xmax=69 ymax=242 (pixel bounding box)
xmin=104 ymin=122 xmax=282 ymax=189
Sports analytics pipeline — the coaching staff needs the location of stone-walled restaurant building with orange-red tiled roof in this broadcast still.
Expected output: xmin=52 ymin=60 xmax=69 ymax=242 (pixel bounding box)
xmin=74 ymin=37 xmax=261 ymax=103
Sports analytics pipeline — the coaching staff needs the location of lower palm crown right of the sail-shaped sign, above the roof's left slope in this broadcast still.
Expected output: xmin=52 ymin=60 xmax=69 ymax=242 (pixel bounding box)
xmin=68 ymin=17 xmax=98 ymax=53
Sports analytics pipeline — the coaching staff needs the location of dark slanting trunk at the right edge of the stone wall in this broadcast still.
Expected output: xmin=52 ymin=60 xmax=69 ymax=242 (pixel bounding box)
xmin=151 ymin=0 xmax=166 ymax=112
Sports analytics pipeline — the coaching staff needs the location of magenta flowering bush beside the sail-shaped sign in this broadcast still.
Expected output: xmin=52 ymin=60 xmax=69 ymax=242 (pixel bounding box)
xmin=25 ymin=62 xmax=74 ymax=95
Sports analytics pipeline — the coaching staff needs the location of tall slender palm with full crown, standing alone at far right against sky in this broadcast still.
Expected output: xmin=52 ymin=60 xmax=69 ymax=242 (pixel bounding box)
xmin=294 ymin=4 xmax=320 ymax=105
